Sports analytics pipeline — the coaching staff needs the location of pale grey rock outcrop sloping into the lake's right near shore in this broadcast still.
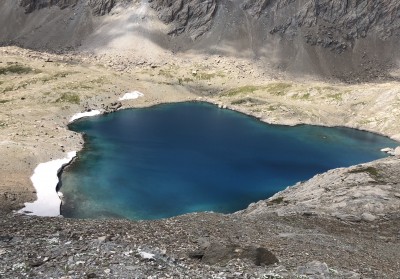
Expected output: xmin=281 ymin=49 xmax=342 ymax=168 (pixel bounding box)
xmin=242 ymin=157 xmax=400 ymax=222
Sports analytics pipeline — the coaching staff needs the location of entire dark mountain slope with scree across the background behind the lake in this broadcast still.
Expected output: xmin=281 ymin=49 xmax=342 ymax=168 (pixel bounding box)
xmin=0 ymin=0 xmax=400 ymax=81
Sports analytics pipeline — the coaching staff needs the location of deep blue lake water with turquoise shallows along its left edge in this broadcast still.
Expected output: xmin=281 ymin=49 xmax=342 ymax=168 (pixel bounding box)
xmin=61 ymin=103 xmax=398 ymax=219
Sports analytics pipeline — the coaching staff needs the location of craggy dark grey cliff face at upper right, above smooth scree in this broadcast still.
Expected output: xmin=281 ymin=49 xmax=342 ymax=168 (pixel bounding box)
xmin=242 ymin=0 xmax=400 ymax=53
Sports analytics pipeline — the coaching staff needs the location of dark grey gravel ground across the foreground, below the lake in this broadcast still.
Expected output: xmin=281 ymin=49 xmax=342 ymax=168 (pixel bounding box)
xmin=0 ymin=213 xmax=400 ymax=278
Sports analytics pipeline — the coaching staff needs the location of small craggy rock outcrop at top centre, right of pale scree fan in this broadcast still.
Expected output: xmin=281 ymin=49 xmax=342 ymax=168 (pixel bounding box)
xmin=149 ymin=0 xmax=217 ymax=40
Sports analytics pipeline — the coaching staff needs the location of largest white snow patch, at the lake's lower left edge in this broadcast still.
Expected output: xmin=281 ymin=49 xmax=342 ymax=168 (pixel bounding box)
xmin=18 ymin=151 xmax=76 ymax=216
